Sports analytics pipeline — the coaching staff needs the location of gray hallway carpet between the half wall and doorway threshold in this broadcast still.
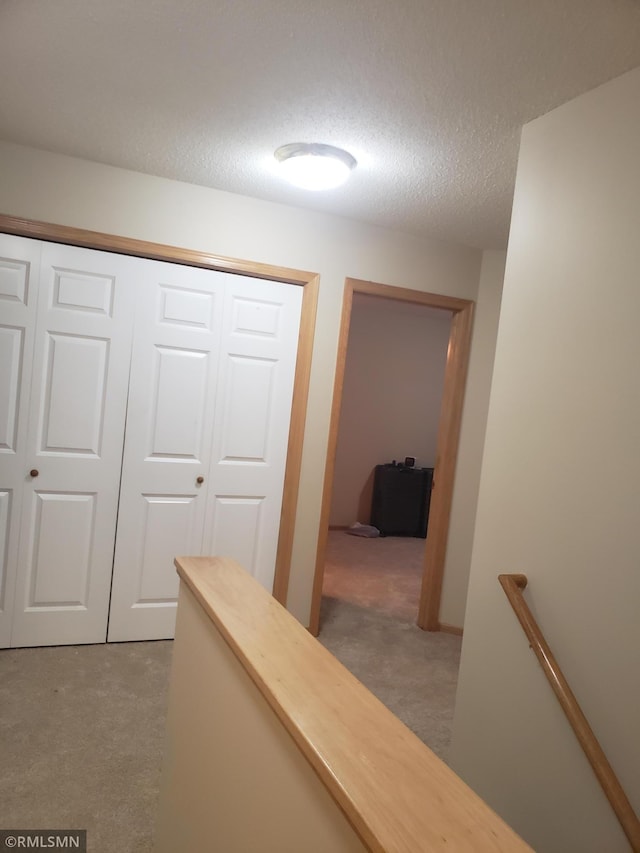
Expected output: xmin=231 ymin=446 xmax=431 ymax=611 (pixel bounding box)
xmin=318 ymin=597 xmax=462 ymax=760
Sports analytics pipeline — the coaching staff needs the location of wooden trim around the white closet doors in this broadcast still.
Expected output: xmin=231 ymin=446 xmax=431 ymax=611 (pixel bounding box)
xmin=0 ymin=214 xmax=320 ymax=605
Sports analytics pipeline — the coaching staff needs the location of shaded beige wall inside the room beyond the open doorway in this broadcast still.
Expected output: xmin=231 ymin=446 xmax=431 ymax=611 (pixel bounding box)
xmin=329 ymin=293 xmax=451 ymax=525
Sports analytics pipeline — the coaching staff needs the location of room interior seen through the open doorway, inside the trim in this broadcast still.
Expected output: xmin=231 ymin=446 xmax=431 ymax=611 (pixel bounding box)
xmin=321 ymin=292 xmax=452 ymax=623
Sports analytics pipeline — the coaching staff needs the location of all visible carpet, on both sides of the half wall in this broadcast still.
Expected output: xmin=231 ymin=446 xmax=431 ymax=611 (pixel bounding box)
xmin=0 ymin=533 xmax=460 ymax=853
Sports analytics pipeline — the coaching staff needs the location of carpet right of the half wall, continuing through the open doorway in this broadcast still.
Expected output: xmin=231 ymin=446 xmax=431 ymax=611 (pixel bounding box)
xmin=318 ymin=530 xmax=462 ymax=760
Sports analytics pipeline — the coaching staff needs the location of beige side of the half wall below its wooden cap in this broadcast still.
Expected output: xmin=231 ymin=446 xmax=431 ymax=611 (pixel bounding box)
xmin=154 ymin=582 xmax=370 ymax=853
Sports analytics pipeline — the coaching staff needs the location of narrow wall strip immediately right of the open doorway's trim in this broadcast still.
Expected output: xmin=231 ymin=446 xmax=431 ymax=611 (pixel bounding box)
xmin=440 ymin=250 xmax=506 ymax=628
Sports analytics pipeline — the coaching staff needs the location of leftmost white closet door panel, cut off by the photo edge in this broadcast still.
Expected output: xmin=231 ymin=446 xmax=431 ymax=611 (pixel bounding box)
xmin=0 ymin=234 xmax=41 ymax=648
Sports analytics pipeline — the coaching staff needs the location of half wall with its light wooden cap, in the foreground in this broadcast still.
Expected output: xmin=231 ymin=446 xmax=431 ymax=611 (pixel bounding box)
xmin=157 ymin=557 xmax=532 ymax=853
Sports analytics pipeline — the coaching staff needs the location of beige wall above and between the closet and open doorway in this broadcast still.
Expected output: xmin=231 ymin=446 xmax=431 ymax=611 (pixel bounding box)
xmin=0 ymin=143 xmax=481 ymax=623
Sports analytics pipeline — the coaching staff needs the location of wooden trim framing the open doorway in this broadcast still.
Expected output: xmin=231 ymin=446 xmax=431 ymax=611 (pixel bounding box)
xmin=309 ymin=278 xmax=475 ymax=636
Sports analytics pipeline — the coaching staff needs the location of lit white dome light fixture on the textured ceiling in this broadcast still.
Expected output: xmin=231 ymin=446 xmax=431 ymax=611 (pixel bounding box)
xmin=273 ymin=142 xmax=357 ymax=190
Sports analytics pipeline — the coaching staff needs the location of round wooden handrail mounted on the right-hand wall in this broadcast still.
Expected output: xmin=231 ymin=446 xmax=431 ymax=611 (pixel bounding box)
xmin=498 ymin=574 xmax=640 ymax=853
